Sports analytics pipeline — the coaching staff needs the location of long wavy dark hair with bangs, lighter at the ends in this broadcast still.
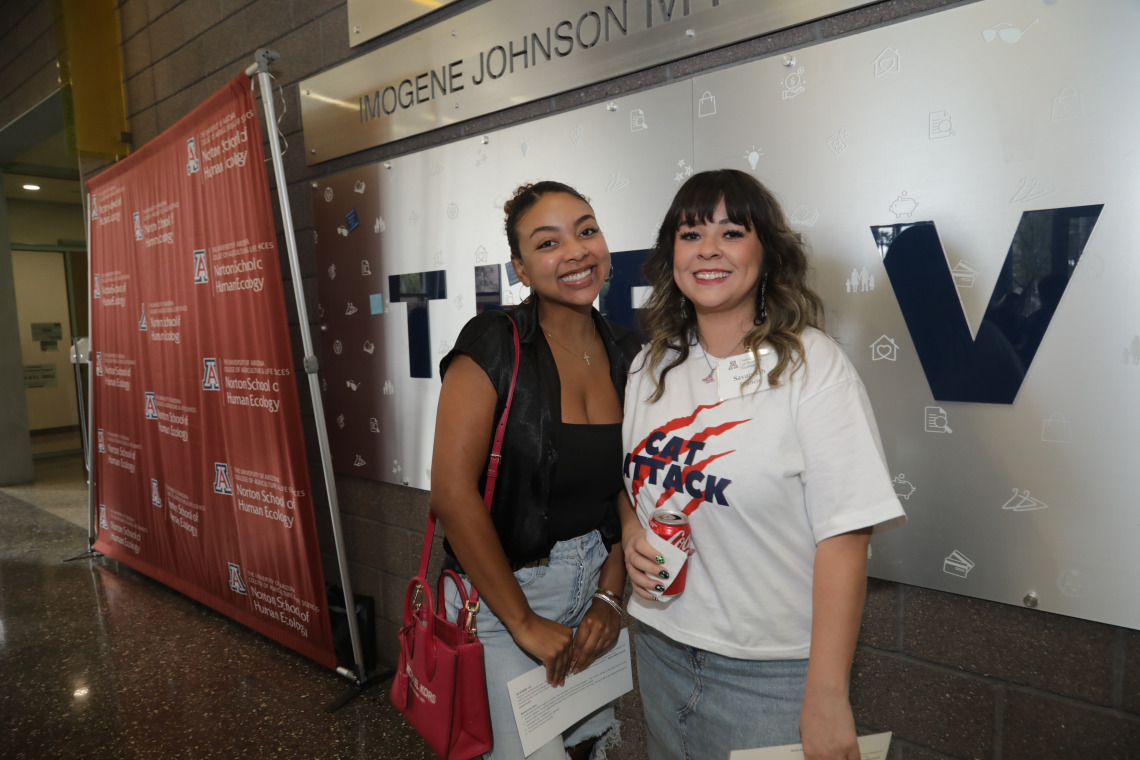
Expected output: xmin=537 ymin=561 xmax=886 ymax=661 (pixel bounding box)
xmin=642 ymin=169 xmax=824 ymax=401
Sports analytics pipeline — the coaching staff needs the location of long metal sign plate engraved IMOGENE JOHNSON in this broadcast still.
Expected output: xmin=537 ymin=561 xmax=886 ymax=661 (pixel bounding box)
xmin=301 ymin=0 xmax=869 ymax=164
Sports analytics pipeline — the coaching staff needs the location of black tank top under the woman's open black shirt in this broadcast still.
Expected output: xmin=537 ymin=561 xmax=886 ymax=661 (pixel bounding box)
xmin=546 ymin=423 xmax=622 ymax=541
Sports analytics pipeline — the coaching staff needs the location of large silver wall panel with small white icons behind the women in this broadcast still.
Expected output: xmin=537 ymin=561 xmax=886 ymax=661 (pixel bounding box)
xmin=315 ymin=0 xmax=1140 ymax=628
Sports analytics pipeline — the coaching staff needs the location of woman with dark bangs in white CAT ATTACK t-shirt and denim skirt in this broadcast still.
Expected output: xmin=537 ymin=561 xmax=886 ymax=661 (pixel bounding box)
xmin=621 ymin=170 xmax=905 ymax=760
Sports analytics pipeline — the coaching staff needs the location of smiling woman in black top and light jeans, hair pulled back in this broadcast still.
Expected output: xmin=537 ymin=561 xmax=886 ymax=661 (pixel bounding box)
xmin=430 ymin=181 xmax=640 ymax=760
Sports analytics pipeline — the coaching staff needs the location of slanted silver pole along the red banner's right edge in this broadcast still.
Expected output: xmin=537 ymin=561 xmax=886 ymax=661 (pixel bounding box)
xmin=245 ymin=48 xmax=367 ymax=686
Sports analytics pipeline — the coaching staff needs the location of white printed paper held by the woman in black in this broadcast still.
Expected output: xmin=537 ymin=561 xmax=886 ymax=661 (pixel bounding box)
xmin=506 ymin=629 xmax=634 ymax=754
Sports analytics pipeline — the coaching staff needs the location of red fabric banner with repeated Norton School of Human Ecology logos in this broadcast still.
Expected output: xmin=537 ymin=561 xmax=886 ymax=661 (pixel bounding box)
xmin=88 ymin=74 xmax=336 ymax=668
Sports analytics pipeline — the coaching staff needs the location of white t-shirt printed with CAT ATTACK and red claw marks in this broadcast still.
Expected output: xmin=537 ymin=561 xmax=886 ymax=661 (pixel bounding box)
xmin=622 ymin=328 xmax=905 ymax=660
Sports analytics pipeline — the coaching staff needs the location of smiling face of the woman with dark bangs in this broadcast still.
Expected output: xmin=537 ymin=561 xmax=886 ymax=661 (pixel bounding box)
xmin=673 ymin=198 xmax=764 ymax=321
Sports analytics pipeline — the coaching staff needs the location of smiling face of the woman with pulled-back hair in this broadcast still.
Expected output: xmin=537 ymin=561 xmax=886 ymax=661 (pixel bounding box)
xmin=511 ymin=193 xmax=610 ymax=307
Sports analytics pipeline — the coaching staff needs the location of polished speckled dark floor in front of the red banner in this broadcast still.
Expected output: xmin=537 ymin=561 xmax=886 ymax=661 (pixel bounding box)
xmin=0 ymin=457 xmax=434 ymax=760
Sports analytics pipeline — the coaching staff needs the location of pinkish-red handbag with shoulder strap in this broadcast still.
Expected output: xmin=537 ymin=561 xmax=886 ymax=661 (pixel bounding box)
xmin=389 ymin=316 xmax=519 ymax=760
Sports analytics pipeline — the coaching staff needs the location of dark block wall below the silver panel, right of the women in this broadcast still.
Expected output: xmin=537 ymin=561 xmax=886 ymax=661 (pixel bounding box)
xmin=852 ymin=580 xmax=1140 ymax=760
